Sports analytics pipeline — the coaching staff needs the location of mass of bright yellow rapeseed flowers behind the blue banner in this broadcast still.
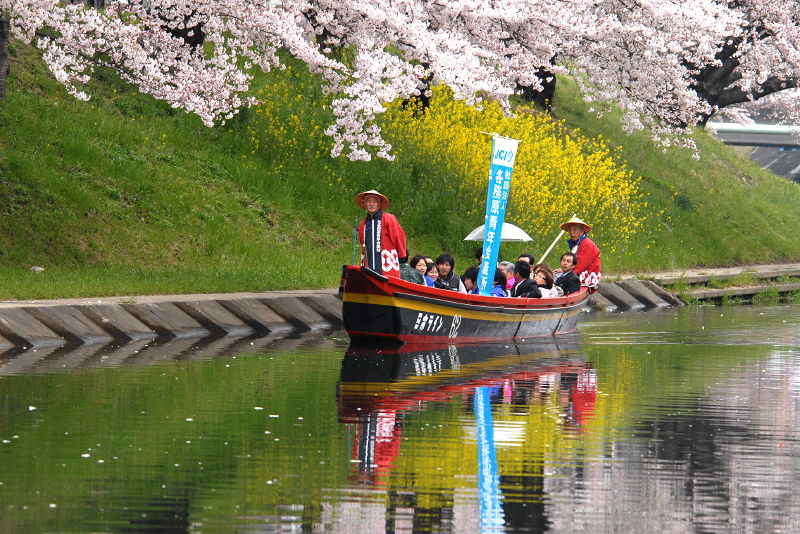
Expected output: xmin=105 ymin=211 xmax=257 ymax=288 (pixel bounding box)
xmin=384 ymin=88 xmax=660 ymax=260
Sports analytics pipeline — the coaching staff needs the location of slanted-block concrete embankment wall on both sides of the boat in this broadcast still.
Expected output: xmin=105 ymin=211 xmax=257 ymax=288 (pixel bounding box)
xmin=0 ymin=264 xmax=800 ymax=357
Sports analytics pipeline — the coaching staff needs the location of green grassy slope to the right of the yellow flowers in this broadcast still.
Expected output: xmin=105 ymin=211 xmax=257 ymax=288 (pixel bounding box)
xmin=554 ymin=78 xmax=800 ymax=271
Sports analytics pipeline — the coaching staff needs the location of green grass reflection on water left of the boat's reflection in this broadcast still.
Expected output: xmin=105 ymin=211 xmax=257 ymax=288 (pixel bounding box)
xmin=0 ymin=347 xmax=350 ymax=533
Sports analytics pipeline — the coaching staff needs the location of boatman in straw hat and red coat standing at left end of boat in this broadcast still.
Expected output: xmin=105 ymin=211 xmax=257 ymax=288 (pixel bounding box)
xmin=355 ymin=189 xmax=408 ymax=277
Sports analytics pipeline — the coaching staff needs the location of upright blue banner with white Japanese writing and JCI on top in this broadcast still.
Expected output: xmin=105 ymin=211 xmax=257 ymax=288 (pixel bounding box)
xmin=478 ymin=135 xmax=519 ymax=295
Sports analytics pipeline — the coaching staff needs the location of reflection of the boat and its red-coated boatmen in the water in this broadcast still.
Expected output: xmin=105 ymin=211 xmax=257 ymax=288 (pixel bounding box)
xmin=338 ymin=343 xmax=597 ymax=483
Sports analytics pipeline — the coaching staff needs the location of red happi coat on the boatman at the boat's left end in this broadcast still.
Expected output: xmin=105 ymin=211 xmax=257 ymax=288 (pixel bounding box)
xmin=358 ymin=210 xmax=408 ymax=277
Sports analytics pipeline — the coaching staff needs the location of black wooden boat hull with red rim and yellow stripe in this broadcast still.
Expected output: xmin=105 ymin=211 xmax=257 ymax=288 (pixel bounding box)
xmin=339 ymin=265 xmax=589 ymax=344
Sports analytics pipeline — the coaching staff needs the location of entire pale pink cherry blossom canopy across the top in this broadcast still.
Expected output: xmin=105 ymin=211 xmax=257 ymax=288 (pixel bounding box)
xmin=0 ymin=0 xmax=797 ymax=160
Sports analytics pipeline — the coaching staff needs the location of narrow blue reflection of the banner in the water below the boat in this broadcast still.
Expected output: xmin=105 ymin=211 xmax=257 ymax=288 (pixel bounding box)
xmin=474 ymin=387 xmax=504 ymax=534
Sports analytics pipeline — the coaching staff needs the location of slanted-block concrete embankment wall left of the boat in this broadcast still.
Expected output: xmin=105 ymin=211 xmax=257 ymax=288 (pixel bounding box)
xmin=0 ymin=289 xmax=342 ymax=352
